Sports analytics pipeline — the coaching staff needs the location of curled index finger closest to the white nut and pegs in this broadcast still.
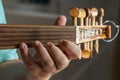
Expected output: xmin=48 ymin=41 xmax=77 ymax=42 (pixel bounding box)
xmin=58 ymin=40 xmax=81 ymax=59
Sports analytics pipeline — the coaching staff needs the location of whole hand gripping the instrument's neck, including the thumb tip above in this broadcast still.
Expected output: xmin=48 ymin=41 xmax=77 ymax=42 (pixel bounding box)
xmin=20 ymin=16 xmax=81 ymax=80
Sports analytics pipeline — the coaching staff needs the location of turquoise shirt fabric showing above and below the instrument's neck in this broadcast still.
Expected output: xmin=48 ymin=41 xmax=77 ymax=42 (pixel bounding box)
xmin=0 ymin=0 xmax=18 ymax=63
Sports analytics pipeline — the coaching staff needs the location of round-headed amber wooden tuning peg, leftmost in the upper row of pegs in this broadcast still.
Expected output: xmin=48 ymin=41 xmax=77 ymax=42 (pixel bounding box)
xmin=69 ymin=7 xmax=80 ymax=26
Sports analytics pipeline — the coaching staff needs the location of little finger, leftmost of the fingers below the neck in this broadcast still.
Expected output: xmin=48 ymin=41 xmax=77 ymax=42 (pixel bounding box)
xmin=19 ymin=43 xmax=33 ymax=66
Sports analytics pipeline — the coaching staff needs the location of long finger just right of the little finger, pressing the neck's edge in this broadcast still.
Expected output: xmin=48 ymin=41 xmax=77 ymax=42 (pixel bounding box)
xmin=34 ymin=41 xmax=56 ymax=72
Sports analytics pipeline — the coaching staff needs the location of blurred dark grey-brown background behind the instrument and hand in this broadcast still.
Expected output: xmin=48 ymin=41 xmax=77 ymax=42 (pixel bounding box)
xmin=3 ymin=0 xmax=120 ymax=80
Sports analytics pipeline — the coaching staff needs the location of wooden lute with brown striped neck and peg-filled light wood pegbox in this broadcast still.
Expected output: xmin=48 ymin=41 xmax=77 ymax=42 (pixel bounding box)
xmin=0 ymin=7 xmax=111 ymax=58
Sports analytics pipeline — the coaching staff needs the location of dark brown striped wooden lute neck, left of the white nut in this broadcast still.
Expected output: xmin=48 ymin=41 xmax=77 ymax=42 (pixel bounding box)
xmin=0 ymin=25 xmax=76 ymax=49
